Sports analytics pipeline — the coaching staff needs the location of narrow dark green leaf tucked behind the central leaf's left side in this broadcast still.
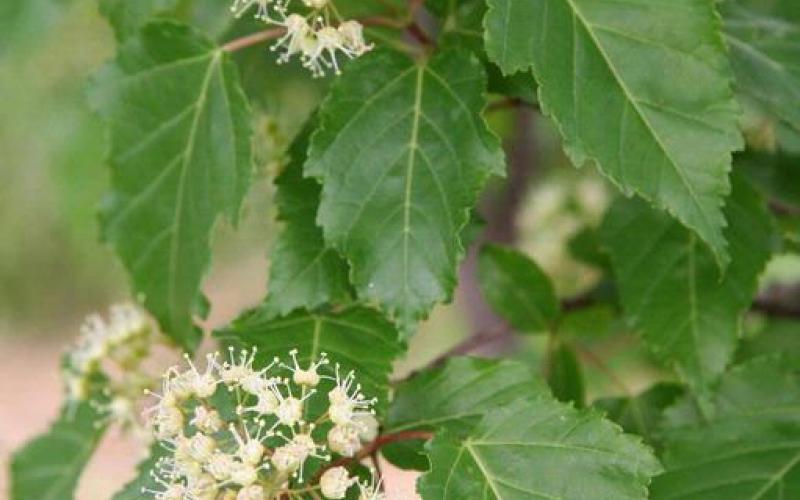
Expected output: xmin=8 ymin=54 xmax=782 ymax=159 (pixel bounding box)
xmin=261 ymin=122 xmax=350 ymax=316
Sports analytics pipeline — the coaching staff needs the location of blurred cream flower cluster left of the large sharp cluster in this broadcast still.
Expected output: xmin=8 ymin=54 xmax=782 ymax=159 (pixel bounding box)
xmin=63 ymin=304 xmax=167 ymax=431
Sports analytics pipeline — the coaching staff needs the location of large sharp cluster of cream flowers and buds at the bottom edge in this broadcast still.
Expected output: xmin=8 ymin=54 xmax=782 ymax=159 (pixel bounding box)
xmin=142 ymin=348 xmax=385 ymax=500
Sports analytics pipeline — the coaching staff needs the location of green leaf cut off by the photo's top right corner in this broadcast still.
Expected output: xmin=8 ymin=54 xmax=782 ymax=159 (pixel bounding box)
xmin=723 ymin=1 xmax=800 ymax=139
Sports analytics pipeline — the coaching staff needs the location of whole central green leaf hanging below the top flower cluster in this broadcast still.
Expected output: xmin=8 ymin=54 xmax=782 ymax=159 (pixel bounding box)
xmin=306 ymin=50 xmax=503 ymax=335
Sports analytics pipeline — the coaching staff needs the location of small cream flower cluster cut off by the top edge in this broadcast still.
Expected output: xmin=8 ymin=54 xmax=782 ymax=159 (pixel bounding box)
xmin=231 ymin=0 xmax=372 ymax=78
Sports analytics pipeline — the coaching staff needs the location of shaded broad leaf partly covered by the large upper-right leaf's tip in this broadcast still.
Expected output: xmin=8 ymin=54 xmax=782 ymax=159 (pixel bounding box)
xmin=603 ymin=177 xmax=774 ymax=387
